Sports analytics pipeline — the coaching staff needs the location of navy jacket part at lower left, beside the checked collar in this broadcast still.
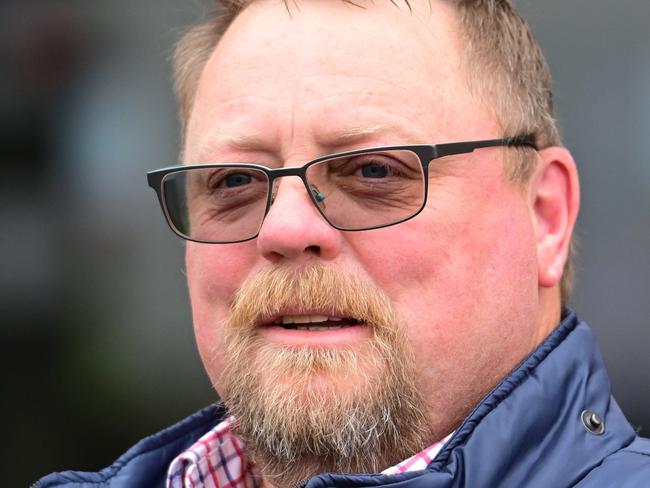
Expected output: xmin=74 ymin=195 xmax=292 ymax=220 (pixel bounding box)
xmin=33 ymin=405 xmax=224 ymax=488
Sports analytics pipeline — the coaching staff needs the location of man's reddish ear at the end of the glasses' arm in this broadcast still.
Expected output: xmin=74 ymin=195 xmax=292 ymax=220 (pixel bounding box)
xmin=531 ymin=147 xmax=580 ymax=288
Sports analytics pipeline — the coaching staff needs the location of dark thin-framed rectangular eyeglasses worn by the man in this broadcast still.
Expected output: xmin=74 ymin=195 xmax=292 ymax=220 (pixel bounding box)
xmin=147 ymin=135 xmax=536 ymax=244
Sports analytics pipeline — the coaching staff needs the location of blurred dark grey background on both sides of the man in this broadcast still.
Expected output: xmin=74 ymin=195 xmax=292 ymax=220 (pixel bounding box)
xmin=0 ymin=0 xmax=650 ymax=486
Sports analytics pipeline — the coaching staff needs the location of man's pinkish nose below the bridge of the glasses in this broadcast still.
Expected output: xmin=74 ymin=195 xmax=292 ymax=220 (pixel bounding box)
xmin=257 ymin=176 xmax=343 ymax=263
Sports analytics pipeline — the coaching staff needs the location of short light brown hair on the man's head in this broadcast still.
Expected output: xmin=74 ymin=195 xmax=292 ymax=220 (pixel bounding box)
xmin=174 ymin=0 xmax=574 ymax=308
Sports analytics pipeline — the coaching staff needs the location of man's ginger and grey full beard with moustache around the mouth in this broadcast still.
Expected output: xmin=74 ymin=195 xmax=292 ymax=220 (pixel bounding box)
xmin=219 ymin=265 xmax=432 ymax=487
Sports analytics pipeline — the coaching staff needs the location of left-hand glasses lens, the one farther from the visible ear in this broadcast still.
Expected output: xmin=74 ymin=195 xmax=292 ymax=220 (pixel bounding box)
xmin=163 ymin=166 xmax=269 ymax=243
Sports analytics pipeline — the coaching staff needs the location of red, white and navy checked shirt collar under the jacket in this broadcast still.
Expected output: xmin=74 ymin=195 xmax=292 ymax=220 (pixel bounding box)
xmin=167 ymin=417 xmax=453 ymax=488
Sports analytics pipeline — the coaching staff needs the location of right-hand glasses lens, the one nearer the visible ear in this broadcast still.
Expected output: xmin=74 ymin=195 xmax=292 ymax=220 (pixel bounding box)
xmin=307 ymin=151 xmax=424 ymax=230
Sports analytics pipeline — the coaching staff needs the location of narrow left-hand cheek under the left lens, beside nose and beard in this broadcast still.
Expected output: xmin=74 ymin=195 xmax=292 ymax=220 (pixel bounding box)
xmin=185 ymin=241 xmax=255 ymax=388
